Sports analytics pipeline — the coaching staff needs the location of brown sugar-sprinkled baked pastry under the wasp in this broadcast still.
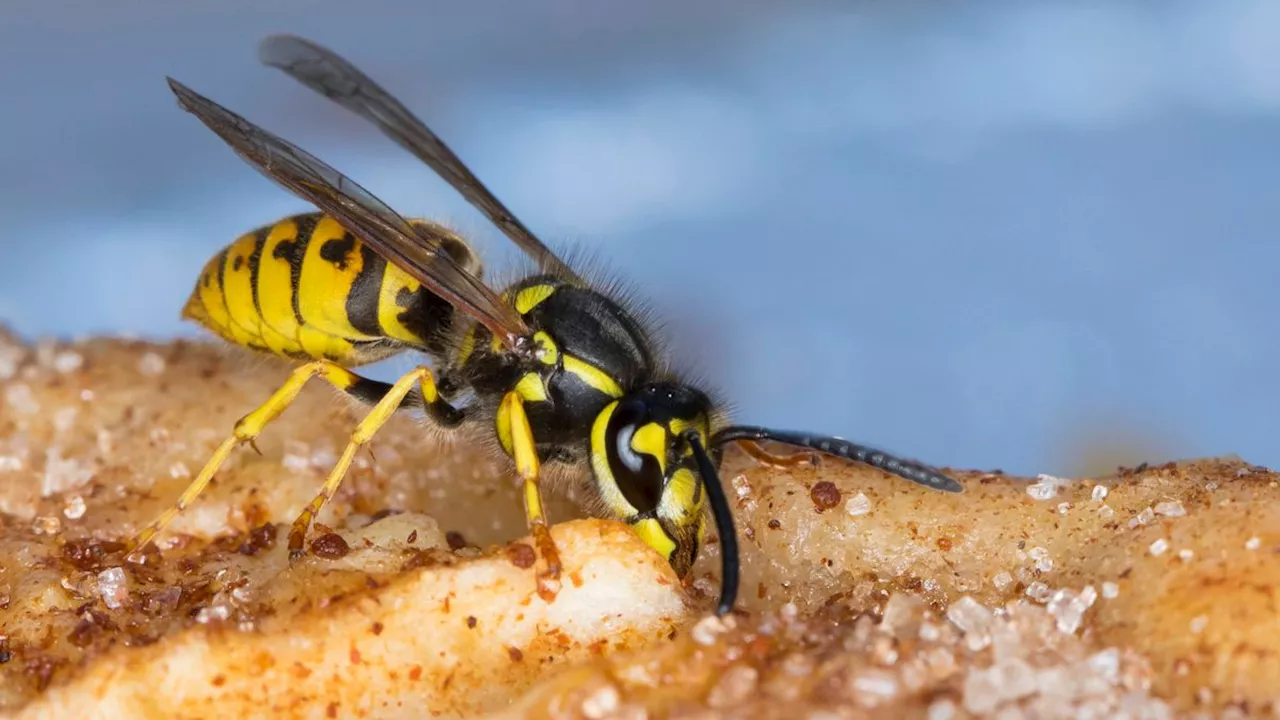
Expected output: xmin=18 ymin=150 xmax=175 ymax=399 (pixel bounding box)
xmin=0 ymin=334 xmax=1280 ymax=719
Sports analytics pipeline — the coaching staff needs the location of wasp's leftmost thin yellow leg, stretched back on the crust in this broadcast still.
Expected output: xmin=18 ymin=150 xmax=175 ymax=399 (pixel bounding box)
xmin=131 ymin=360 xmax=360 ymax=550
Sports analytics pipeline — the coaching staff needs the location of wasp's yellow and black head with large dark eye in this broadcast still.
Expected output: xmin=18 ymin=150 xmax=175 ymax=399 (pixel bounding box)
xmin=591 ymin=383 xmax=710 ymax=575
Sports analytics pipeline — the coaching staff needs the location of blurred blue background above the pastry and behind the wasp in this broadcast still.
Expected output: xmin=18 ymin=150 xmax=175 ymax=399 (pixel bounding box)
xmin=0 ymin=0 xmax=1280 ymax=474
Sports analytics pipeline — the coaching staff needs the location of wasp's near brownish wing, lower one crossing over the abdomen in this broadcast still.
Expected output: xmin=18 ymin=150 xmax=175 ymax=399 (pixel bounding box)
xmin=169 ymin=78 xmax=529 ymax=350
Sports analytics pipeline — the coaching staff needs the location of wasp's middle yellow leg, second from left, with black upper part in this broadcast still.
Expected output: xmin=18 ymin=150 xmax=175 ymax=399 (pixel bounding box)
xmin=289 ymin=368 xmax=463 ymax=559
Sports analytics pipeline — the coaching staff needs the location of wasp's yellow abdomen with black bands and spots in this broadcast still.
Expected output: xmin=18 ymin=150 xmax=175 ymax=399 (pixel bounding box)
xmin=183 ymin=213 xmax=480 ymax=366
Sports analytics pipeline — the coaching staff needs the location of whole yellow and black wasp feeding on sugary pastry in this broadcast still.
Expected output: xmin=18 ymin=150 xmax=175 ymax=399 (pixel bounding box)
xmin=133 ymin=35 xmax=963 ymax=615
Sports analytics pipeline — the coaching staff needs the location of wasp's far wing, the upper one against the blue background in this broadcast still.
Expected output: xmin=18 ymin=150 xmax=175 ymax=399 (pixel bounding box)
xmin=259 ymin=35 xmax=577 ymax=278
